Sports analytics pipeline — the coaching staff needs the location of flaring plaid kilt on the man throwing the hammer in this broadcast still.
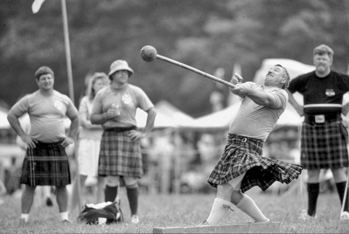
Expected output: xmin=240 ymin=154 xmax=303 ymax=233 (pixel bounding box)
xmin=207 ymin=134 xmax=302 ymax=193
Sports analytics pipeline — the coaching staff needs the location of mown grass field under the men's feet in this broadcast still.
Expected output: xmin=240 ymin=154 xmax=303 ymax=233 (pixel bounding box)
xmin=0 ymin=185 xmax=349 ymax=233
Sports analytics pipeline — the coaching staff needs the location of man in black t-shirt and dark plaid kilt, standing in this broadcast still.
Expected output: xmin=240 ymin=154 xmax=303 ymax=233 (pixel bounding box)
xmin=288 ymin=45 xmax=349 ymax=219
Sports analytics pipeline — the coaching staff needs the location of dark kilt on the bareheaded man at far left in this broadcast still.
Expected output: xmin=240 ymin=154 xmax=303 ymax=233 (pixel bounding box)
xmin=21 ymin=142 xmax=71 ymax=187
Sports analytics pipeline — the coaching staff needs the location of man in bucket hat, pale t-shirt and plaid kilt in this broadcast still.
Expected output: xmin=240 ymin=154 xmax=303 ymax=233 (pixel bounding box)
xmin=91 ymin=60 xmax=156 ymax=224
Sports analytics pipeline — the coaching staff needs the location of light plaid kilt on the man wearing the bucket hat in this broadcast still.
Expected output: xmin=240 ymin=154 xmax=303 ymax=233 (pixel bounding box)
xmin=98 ymin=131 xmax=143 ymax=178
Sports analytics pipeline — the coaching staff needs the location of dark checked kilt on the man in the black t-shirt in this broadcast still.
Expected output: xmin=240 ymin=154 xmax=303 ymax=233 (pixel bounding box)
xmin=301 ymin=119 xmax=348 ymax=169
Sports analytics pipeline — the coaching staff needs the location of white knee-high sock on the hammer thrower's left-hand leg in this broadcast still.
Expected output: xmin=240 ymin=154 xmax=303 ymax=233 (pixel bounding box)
xmin=206 ymin=198 xmax=234 ymax=225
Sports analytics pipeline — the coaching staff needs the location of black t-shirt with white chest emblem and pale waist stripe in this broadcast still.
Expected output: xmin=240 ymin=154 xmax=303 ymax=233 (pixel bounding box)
xmin=288 ymin=71 xmax=349 ymax=114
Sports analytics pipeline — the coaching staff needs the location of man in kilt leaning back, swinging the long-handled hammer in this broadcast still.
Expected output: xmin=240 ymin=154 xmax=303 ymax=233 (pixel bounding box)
xmin=202 ymin=65 xmax=302 ymax=225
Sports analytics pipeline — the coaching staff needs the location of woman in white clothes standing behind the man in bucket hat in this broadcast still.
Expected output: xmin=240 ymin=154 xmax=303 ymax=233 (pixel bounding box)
xmin=70 ymin=72 xmax=109 ymax=210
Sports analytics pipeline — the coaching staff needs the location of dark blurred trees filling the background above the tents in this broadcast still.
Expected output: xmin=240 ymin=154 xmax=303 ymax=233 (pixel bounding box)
xmin=0 ymin=0 xmax=349 ymax=116
